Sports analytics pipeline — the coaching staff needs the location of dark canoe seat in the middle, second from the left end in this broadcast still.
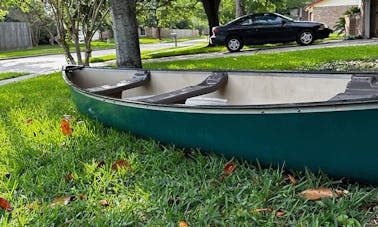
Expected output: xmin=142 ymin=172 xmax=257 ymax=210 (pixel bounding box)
xmin=137 ymin=72 xmax=228 ymax=104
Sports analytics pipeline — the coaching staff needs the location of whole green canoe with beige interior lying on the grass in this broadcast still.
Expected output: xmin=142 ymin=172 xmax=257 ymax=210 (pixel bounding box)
xmin=62 ymin=66 xmax=378 ymax=184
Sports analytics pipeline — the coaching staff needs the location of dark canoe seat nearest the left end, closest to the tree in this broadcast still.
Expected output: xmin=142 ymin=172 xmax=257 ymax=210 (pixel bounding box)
xmin=86 ymin=70 xmax=151 ymax=95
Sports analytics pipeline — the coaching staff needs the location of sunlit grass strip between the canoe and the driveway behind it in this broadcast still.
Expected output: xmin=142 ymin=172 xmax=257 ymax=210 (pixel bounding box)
xmin=143 ymin=45 xmax=378 ymax=70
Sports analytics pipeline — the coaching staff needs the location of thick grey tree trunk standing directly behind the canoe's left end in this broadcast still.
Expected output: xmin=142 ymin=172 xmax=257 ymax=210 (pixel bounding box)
xmin=110 ymin=0 xmax=142 ymax=68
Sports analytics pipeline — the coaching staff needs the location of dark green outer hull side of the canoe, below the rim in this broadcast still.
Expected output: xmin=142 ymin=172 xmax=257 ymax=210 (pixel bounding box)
xmin=71 ymin=87 xmax=378 ymax=184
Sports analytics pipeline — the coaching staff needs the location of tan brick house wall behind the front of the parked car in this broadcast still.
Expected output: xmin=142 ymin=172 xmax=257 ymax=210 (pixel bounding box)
xmin=312 ymin=5 xmax=353 ymax=28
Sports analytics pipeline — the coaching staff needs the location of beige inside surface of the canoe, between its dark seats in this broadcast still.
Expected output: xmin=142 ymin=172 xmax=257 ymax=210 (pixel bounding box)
xmin=71 ymin=68 xmax=352 ymax=105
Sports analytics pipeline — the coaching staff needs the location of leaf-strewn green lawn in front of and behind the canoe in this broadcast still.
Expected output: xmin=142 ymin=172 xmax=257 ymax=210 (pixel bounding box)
xmin=0 ymin=44 xmax=378 ymax=226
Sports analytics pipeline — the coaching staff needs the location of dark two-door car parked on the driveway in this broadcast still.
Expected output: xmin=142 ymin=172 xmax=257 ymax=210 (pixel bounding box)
xmin=210 ymin=13 xmax=332 ymax=52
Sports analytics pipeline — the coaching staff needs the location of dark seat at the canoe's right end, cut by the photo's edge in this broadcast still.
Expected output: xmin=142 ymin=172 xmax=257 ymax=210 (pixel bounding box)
xmin=330 ymin=74 xmax=378 ymax=101
